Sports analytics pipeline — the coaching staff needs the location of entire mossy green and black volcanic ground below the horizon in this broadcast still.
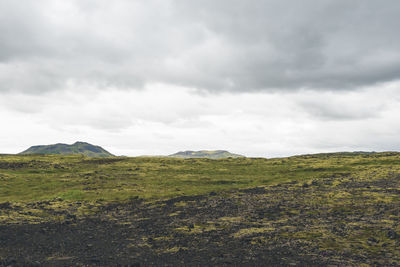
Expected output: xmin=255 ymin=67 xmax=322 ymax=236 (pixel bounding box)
xmin=0 ymin=153 xmax=400 ymax=266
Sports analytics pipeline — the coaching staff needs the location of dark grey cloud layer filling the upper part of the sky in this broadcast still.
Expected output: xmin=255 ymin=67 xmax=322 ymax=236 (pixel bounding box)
xmin=0 ymin=0 xmax=400 ymax=94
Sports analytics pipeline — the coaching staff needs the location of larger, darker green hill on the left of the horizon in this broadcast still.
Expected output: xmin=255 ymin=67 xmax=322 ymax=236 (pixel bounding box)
xmin=19 ymin=142 xmax=114 ymax=157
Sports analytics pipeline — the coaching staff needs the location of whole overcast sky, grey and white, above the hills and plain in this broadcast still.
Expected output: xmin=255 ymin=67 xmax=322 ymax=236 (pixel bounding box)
xmin=0 ymin=0 xmax=400 ymax=157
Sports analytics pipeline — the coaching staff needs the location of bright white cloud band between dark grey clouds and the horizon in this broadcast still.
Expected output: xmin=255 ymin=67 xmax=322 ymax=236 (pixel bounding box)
xmin=0 ymin=82 xmax=400 ymax=157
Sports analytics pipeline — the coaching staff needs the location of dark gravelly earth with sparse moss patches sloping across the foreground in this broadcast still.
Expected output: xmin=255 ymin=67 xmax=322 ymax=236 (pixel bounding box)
xmin=0 ymin=177 xmax=400 ymax=266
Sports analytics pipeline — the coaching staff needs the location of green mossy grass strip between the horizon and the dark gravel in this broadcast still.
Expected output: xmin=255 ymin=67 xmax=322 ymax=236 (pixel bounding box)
xmin=0 ymin=153 xmax=376 ymax=202
